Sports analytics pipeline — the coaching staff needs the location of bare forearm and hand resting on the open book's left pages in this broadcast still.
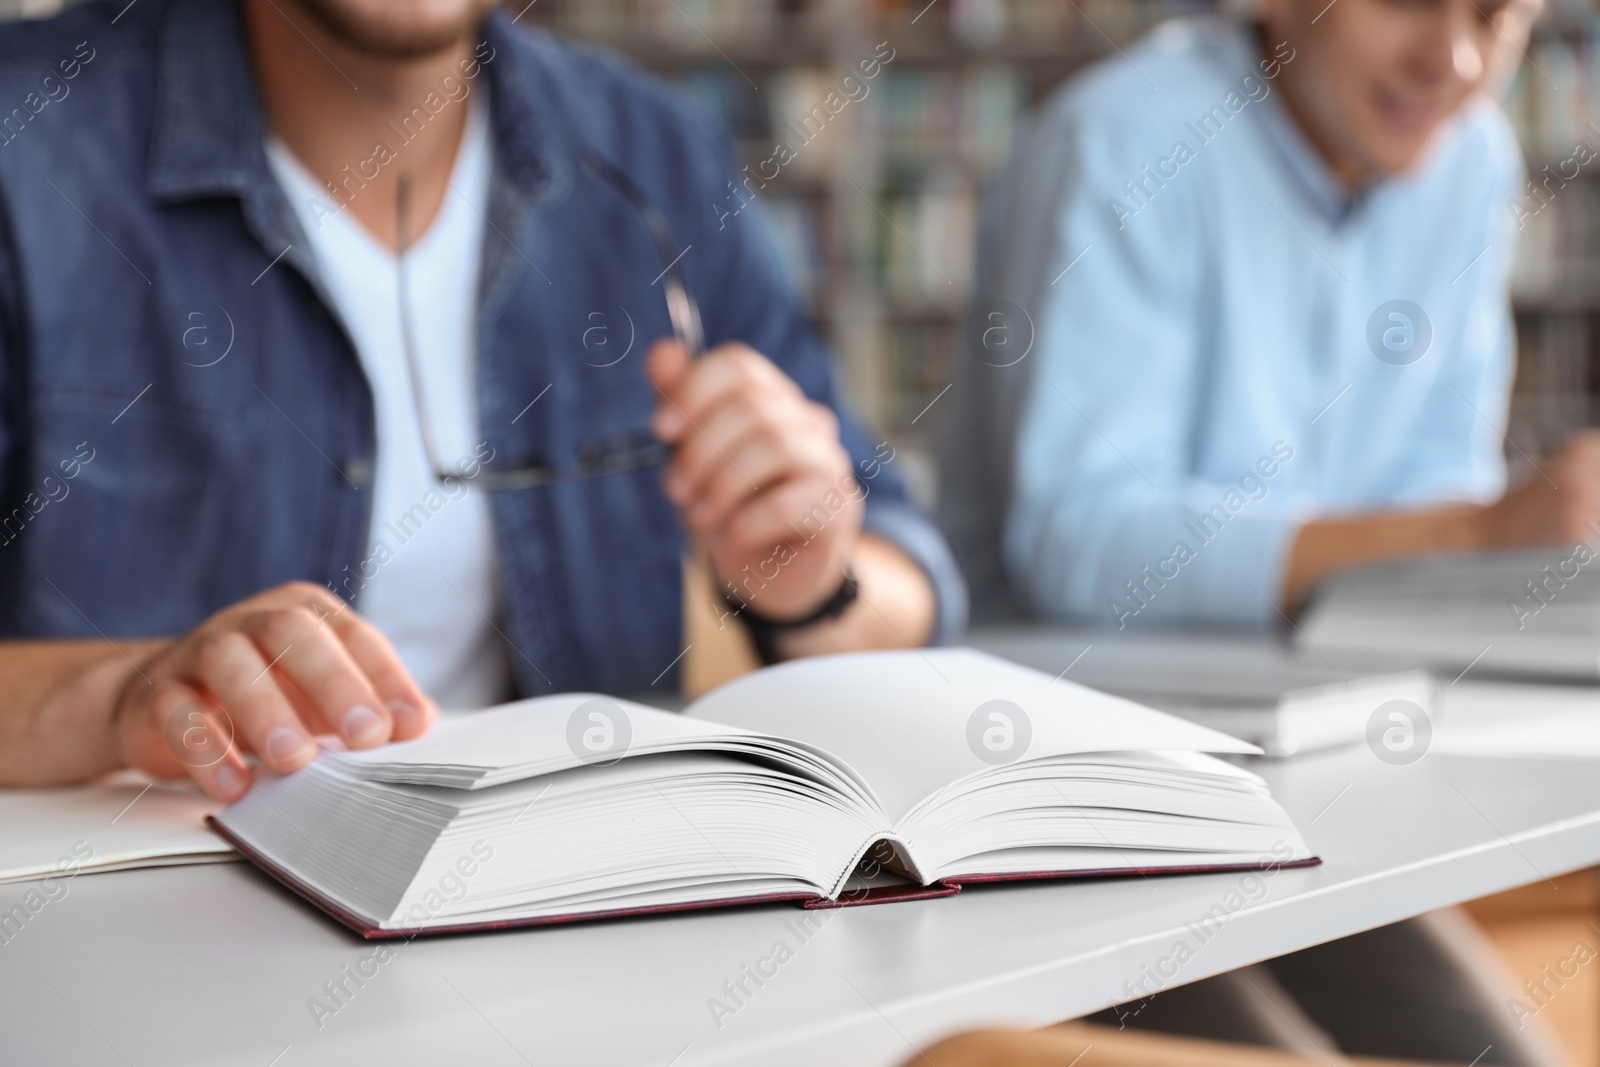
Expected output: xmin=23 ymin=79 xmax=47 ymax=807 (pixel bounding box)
xmin=0 ymin=582 xmax=438 ymax=800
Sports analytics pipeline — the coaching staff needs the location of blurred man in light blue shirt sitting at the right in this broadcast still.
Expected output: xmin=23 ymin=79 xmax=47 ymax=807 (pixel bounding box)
xmin=974 ymin=0 xmax=1600 ymax=627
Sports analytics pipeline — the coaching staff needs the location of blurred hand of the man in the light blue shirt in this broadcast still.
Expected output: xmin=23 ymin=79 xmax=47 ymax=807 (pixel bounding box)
xmin=1480 ymin=430 xmax=1600 ymax=549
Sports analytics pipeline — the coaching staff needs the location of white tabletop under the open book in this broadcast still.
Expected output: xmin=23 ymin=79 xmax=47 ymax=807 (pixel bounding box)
xmin=0 ymin=633 xmax=1600 ymax=1067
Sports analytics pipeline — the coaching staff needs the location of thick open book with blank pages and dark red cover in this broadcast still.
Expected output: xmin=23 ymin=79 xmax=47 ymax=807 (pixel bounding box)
xmin=216 ymin=649 xmax=1315 ymax=937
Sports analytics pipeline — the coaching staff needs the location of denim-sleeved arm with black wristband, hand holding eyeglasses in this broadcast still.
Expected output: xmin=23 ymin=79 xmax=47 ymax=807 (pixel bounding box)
xmin=630 ymin=95 xmax=966 ymax=657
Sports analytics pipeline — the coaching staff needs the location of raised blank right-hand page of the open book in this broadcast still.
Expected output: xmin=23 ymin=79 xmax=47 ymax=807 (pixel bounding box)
xmin=685 ymin=648 xmax=1261 ymax=822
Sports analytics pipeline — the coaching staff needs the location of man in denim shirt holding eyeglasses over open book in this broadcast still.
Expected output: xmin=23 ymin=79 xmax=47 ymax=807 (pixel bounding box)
xmin=0 ymin=0 xmax=965 ymax=800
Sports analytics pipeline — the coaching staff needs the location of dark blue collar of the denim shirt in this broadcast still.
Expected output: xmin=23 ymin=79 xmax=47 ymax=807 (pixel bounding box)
xmin=146 ymin=0 xmax=574 ymax=209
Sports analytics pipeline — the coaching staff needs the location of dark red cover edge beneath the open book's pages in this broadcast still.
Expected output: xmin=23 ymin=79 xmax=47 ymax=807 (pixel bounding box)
xmin=206 ymin=816 xmax=1322 ymax=941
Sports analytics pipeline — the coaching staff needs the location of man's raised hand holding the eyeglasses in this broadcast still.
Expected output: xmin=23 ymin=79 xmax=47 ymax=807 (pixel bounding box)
xmin=648 ymin=341 xmax=866 ymax=619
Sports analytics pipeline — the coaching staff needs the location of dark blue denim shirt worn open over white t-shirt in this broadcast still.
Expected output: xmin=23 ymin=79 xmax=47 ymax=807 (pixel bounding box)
xmin=0 ymin=0 xmax=966 ymax=694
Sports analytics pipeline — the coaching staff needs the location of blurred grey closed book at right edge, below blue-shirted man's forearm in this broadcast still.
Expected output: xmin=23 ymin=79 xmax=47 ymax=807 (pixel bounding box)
xmin=1299 ymin=544 xmax=1600 ymax=681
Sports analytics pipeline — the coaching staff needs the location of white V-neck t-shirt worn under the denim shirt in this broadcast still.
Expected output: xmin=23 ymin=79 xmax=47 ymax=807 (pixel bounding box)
xmin=267 ymin=93 xmax=510 ymax=707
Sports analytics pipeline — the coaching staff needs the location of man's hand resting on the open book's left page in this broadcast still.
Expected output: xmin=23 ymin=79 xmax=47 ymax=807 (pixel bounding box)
xmin=112 ymin=582 xmax=438 ymax=800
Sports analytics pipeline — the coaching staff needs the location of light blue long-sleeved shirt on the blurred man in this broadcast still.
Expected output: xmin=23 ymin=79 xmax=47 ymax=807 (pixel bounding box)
xmin=990 ymin=16 xmax=1523 ymax=625
